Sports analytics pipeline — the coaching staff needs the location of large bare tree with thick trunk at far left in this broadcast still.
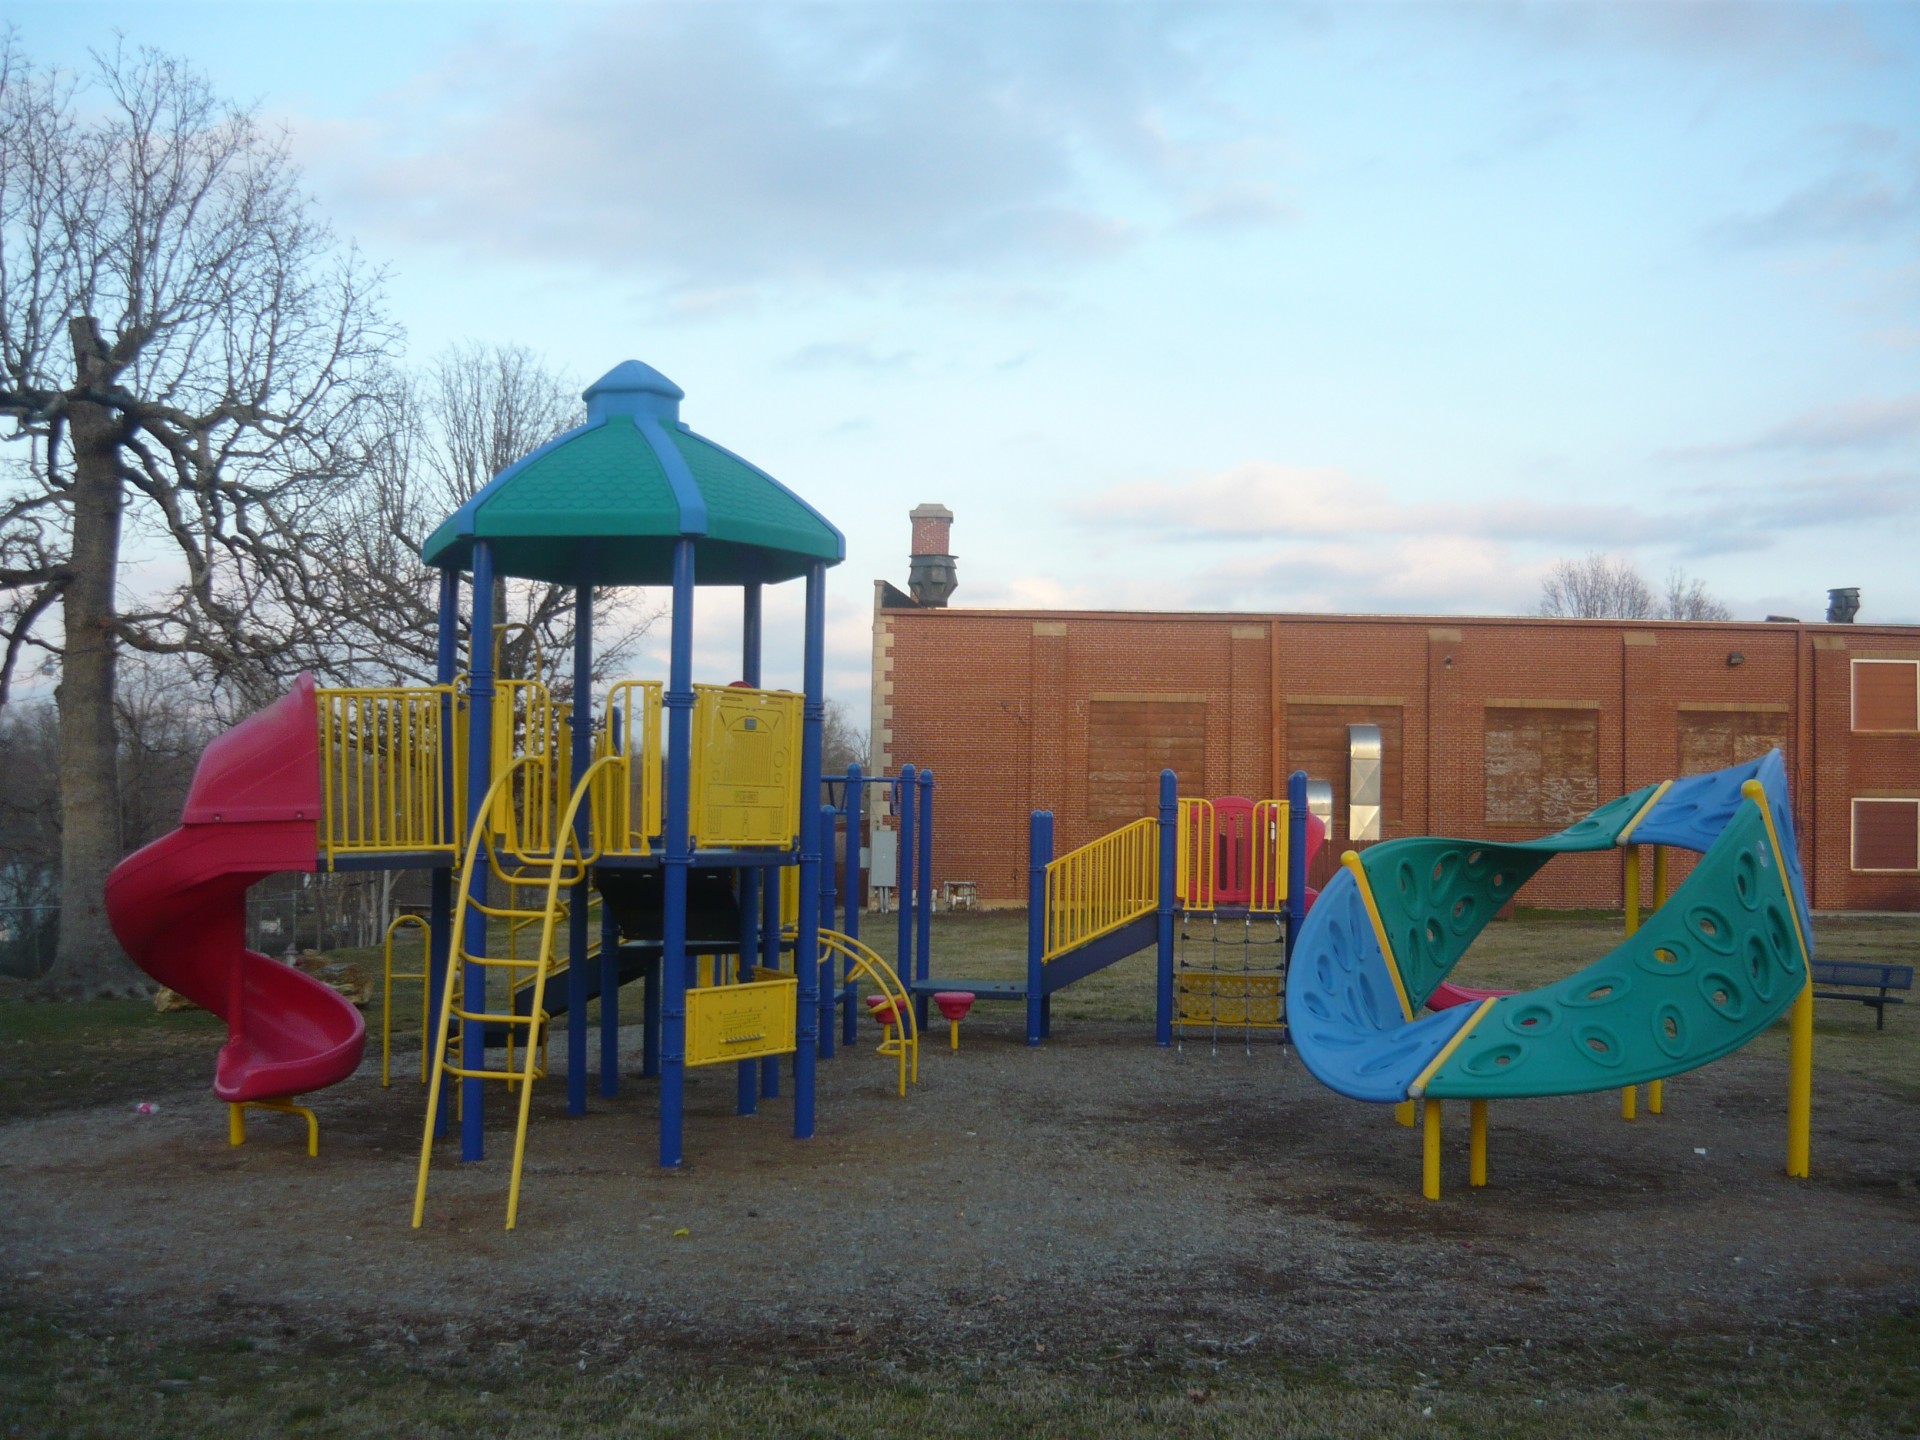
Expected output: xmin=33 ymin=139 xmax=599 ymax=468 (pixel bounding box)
xmin=0 ymin=33 xmax=397 ymax=996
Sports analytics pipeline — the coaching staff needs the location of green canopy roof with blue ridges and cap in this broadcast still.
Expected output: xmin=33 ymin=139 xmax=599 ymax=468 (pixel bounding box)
xmin=420 ymin=361 xmax=847 ymax=586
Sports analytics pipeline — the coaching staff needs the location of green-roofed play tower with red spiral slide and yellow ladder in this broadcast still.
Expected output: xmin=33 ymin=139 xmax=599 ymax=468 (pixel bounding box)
xmin=108 ymin=361 xmax=918 ymax=1229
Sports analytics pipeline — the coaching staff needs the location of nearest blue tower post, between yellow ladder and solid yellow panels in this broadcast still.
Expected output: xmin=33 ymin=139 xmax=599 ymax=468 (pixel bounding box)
xmin=660 ymin=536 xmax=693 ymax=1167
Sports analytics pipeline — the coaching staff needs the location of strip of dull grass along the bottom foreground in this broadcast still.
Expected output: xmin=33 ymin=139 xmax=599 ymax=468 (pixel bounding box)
xmin=0 ymin=1309 xmax=1920 ymax=1440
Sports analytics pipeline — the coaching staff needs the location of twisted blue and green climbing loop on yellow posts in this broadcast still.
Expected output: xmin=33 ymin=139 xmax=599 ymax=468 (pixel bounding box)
xmin=1286 ymin=751 xmax=1812 ymax=1200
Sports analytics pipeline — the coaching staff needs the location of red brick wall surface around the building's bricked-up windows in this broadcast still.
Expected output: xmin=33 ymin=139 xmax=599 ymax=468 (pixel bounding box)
xmin=876 ymin=609 xmax=1920 ymax=910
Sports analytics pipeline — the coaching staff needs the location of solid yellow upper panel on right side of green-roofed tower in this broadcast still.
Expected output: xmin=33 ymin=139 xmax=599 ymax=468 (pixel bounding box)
xmin=687 ymin=685 xmax=803 ymax=851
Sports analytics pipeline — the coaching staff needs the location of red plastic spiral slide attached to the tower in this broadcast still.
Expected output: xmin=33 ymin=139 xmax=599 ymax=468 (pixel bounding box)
xmin=106 ymin=676 xmax=367 ymax=1102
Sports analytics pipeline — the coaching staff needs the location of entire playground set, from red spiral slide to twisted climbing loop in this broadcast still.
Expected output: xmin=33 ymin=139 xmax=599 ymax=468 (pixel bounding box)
xmin=108 ymin=361 xmax=1811 ymax=1229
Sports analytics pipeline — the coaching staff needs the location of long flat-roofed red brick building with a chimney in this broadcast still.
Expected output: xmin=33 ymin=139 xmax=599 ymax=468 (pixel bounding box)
xmin=872 ymin=505 xmax=1920 ymax=910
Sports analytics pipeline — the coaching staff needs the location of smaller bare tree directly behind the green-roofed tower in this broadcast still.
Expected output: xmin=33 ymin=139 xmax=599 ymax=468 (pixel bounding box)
xmin=311 ymin=346 xmax=653 ymax=691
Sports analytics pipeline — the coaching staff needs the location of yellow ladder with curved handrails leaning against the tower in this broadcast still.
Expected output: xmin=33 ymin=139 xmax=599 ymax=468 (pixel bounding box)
xmin=413 ymin=756 xmax=607 ymax=1231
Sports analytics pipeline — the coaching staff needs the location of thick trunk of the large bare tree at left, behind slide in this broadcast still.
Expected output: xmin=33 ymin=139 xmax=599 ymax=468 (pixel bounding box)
xmin=40 ymin=319 xmax=148 ymax=1000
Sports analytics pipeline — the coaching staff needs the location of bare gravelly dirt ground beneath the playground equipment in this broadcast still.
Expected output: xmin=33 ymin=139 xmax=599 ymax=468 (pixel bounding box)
xmin=0 ymin=960 xmax=1920 ymax=1369
